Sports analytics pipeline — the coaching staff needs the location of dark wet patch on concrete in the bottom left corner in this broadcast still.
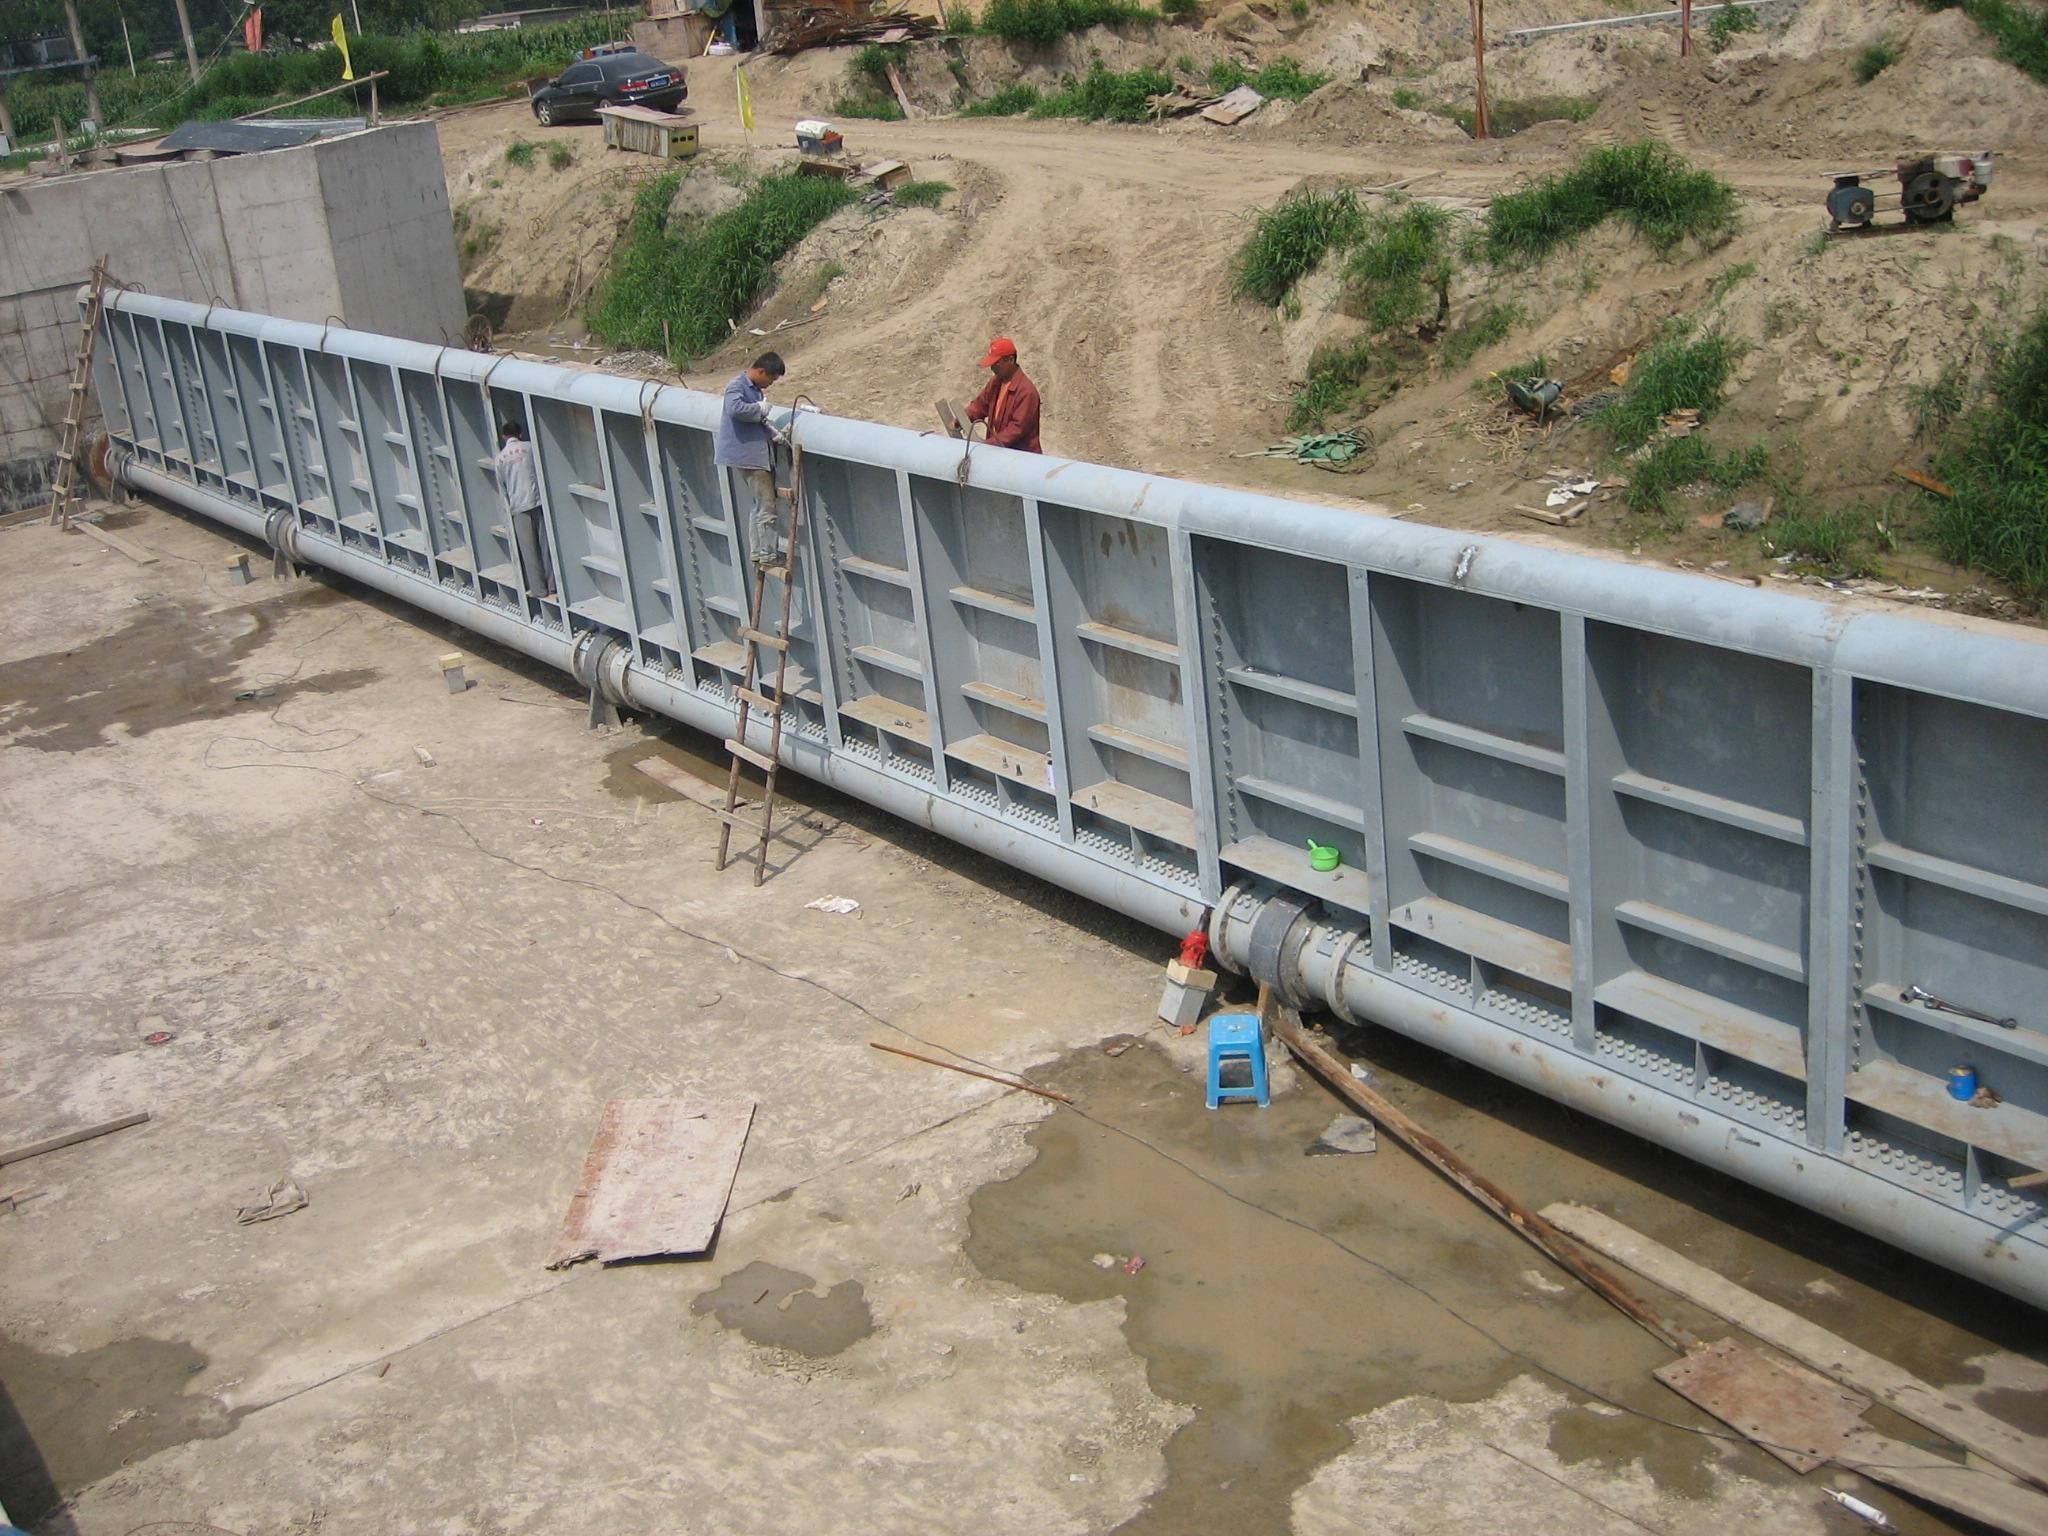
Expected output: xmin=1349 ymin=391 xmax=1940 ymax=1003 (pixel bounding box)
xmin=0 ymin=1339 xmax=240 ymax=1524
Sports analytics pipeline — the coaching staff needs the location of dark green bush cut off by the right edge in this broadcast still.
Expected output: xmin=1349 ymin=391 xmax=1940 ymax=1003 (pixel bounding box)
xmin=1929 ymin=307 xmax=2048 ymax=606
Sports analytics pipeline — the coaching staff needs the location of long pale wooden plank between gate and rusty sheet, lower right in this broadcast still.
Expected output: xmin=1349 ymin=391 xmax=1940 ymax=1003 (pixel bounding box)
xmin=1542 ymin=1202 xmax=2048 ymax=1487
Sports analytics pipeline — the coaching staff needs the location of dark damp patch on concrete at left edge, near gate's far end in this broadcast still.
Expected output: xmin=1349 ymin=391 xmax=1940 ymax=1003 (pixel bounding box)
xmin=0 ymin=588 xmax=377 ymax=752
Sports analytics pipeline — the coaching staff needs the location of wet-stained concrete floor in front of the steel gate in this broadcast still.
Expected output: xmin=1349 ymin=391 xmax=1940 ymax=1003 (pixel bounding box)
xmin=0 ymin=508 xmax=2048 ymax=1536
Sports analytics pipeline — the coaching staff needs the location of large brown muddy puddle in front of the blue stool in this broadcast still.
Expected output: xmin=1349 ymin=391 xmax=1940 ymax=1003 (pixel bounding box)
xmin=967 ymin=1047 xmax=1516 ymax=1536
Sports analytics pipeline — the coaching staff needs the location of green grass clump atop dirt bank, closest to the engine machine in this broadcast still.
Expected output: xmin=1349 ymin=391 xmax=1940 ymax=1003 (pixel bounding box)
xmin=1483 ymin=139 xmax=1735 ymax=266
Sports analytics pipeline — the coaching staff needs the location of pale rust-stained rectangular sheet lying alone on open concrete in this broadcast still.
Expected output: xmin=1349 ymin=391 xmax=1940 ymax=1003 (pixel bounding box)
xmin=547 ymin=1098 xmax=754 ymax=1270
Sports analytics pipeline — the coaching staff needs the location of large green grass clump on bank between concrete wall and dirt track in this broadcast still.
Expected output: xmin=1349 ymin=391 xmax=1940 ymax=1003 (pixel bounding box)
xmin=586 ymin=170 xmax=860 ymax=365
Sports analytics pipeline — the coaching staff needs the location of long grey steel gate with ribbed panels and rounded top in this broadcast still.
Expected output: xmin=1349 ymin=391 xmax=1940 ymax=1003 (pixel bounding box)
xmin=96 ymin=293 xmax=2048 ymax=1305
